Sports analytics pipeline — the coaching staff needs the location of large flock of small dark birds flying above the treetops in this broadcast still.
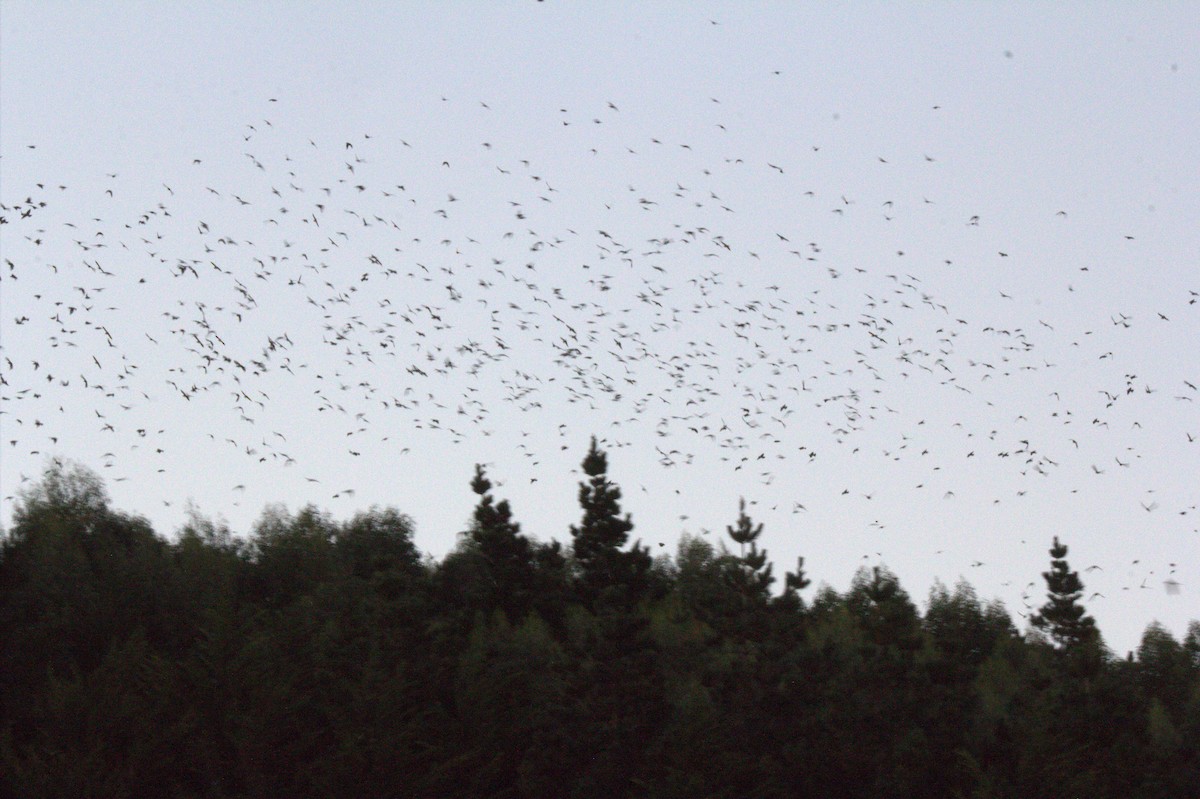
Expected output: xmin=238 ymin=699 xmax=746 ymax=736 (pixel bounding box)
xmin=0 ymin=73 xmax=1200 ymax=643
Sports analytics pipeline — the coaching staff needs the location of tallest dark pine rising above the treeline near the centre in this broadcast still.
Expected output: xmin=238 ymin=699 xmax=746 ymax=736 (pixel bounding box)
xmin=571 ymin=437 xmax=652 ymax=608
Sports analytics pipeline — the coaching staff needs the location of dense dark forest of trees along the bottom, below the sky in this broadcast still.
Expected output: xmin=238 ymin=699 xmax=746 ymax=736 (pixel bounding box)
xmin=0 ymin=440 xmax=1200 ymax=799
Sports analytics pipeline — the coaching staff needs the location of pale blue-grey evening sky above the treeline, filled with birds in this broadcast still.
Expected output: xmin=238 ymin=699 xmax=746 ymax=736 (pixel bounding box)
xmin=0 ymin=0 xmax=1200 ymax=655
